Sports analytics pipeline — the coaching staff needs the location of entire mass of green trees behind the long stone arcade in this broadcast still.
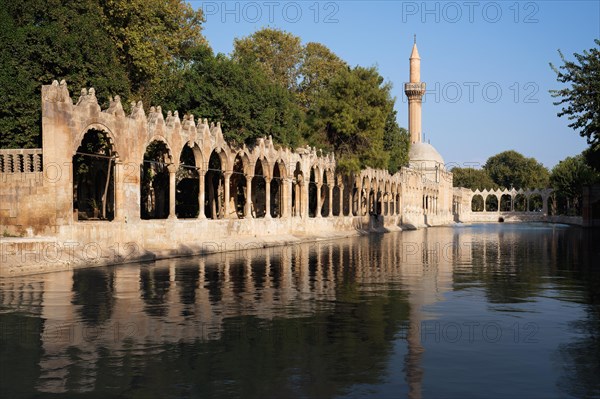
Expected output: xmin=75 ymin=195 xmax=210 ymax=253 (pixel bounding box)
xmin=0 ymin=10 xmax=408 ymax=172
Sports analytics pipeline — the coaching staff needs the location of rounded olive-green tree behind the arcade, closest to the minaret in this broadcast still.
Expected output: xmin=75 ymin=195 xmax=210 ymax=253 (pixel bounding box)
xmin=308 ymin=66 xmax=394 ymax=172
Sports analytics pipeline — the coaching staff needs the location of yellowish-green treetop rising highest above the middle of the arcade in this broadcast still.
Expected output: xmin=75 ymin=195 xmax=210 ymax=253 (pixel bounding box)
xmin=233 ymin=28 xmax=303 ymax=91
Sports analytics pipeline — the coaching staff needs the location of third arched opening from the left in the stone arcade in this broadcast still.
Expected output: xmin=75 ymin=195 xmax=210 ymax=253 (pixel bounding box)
xmin=175 ymin=145 xmax=200 ymax=219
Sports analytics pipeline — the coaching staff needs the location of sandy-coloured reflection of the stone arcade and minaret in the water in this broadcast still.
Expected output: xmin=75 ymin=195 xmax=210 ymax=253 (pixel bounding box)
xmin=0 ymin=229 xmax=472 ymax=392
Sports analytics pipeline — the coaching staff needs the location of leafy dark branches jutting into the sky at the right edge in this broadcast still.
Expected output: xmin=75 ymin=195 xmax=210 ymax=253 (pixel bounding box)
xmin=550 ymin=39 xmax=600 ymax=170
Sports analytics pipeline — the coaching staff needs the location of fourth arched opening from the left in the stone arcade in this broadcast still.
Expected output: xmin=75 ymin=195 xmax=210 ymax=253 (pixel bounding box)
xmin=204 ymin=150 xmax=225 ymax=219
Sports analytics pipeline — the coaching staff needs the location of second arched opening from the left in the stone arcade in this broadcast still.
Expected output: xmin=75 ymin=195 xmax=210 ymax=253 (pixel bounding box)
xmin=140 ymin=140 xmax=172 ymax=219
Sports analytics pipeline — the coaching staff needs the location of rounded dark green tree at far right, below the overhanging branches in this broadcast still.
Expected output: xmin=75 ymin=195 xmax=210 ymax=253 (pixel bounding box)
xmin=550 ymin=154 xmax=600 ymax=213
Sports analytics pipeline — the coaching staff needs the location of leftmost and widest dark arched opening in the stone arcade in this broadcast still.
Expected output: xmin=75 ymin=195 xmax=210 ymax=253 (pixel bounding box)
xmin=73 ymin=129 xmax=116 ymax=220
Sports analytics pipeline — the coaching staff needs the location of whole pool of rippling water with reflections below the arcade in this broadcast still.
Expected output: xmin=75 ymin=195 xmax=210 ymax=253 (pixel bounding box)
xmin=0 ymin=224 xmax=600 ymax=398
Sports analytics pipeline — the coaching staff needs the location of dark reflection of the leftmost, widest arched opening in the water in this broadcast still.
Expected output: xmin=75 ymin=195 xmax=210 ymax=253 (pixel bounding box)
xmin=73 ymin=269 xmax=115 ymax=325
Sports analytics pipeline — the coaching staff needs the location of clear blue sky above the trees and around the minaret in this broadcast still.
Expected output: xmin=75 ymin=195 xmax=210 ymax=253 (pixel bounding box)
xmin=191 ymin=0 xmax=600 ymax=168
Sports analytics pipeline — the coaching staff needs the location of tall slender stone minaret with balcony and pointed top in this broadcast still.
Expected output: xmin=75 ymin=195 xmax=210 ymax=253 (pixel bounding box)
xmin=404 ymin=35 xmax=425 ymax=143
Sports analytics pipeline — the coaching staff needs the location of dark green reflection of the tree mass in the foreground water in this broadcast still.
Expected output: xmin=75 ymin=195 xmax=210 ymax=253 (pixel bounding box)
xmin=89 ymin=287 xmax=408 ymax=398
